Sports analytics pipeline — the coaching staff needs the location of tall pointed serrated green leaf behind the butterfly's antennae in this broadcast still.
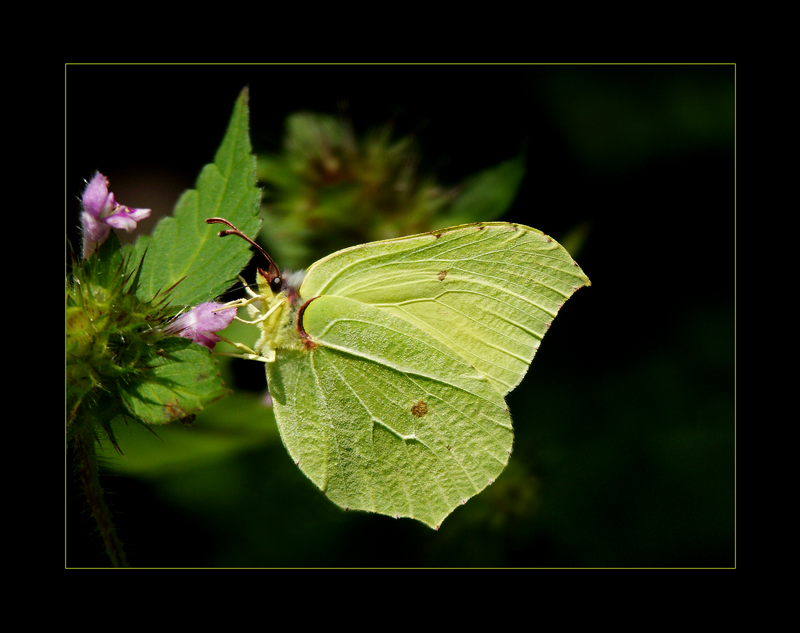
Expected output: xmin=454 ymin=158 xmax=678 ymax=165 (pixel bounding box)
xmin=132 ymin=88 xmax=261 ymax=305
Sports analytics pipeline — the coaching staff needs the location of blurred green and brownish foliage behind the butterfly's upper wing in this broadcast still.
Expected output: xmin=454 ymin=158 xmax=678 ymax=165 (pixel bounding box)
xmin=258 ymin=112 xmax=525 ymax=269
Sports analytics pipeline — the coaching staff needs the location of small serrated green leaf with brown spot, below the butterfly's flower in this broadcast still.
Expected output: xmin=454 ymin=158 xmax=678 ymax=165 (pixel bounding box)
xmin=120 ymin=337 xmax=229 ymax=424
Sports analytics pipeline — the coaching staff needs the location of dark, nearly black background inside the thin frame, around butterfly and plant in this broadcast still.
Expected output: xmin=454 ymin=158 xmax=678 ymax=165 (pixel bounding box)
xmin=65 ymin=65 xmax=735 ymax=567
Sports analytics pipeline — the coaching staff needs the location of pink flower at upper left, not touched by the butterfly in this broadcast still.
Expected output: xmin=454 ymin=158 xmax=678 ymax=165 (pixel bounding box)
xmin=81 ymin=171 xmax=150 ymax=259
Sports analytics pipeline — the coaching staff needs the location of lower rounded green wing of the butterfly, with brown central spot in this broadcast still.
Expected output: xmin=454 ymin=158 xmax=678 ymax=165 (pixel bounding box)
xmin=267 ymin=295 xmax=513 ymax=527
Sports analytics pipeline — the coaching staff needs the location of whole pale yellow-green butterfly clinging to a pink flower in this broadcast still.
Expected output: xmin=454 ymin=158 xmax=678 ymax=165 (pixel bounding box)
xmin=207 ymin=218 xmax=590 ymax=529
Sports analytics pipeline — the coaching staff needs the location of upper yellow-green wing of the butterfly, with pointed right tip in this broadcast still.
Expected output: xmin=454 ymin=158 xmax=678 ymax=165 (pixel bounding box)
xmin=300 ymin=222 xmax=590 ymax=395
